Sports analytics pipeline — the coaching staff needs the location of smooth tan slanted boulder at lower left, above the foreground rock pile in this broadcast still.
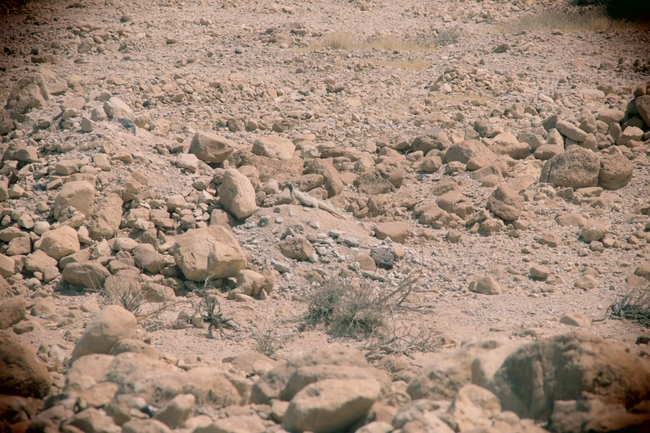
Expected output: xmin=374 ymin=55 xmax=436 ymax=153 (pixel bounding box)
xmin=72 ymin=305 xmax=138 ymax=361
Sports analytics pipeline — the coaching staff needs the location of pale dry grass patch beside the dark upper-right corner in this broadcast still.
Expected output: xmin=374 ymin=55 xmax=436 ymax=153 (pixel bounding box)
xmin=495 ymin=10 xmax=650 ymax=34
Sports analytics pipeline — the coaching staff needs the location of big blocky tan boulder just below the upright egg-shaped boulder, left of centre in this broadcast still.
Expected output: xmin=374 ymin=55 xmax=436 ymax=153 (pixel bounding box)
xmin=172 ymin=225 xmax=246 ymax=282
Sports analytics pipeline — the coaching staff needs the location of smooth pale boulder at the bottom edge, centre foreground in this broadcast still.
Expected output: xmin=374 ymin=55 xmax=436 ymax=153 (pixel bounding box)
xmin=282 ymin=379 xmax=380 ymax=433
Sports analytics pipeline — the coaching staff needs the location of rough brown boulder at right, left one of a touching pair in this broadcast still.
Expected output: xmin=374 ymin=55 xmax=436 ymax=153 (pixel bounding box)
xmin=539 ymin=146 xmax=600 ymax=188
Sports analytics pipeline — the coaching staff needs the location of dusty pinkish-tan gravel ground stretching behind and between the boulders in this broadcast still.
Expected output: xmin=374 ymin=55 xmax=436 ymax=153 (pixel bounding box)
xmin=0 ymin=0 xmax=650 ymax=392
